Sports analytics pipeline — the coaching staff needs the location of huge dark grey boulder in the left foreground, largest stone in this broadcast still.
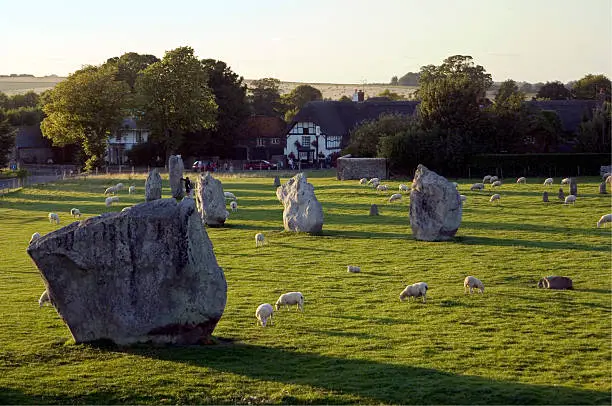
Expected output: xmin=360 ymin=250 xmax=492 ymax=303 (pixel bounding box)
xmin=27 ymin=199 xmax=227 ymax=345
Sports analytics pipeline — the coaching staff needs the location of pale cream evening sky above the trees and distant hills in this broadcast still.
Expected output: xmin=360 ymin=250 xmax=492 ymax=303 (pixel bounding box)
xmin=0 ymin=0 xmax=612 ymax=83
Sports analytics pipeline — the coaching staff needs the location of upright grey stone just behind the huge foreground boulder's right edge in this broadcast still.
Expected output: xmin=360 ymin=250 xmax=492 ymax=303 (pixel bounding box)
xmin=195 ymin=172 xmax=229 ymax=227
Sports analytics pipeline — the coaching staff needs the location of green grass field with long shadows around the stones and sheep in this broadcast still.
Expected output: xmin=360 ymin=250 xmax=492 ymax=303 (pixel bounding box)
xmin=0 ymin=174 xmax=612 ymax=405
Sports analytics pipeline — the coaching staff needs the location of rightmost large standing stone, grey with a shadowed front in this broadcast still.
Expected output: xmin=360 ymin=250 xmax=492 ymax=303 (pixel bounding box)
xmin=410 ymin=165 xmax=462 ymax=241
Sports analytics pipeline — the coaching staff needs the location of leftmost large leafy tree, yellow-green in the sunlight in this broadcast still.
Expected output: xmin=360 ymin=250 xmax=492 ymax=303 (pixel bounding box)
xmin=41 ymin=65 xmax=129 ymax=169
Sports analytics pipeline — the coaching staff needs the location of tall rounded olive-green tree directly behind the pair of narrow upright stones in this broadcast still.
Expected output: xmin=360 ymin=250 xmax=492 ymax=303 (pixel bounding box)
xmin=136 ymin=47 xmax=217 ymax=161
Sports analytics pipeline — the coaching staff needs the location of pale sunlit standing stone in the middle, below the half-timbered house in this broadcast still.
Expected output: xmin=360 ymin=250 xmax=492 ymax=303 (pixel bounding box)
xmin=276 ymin=173 xmax=323 ymax=233
